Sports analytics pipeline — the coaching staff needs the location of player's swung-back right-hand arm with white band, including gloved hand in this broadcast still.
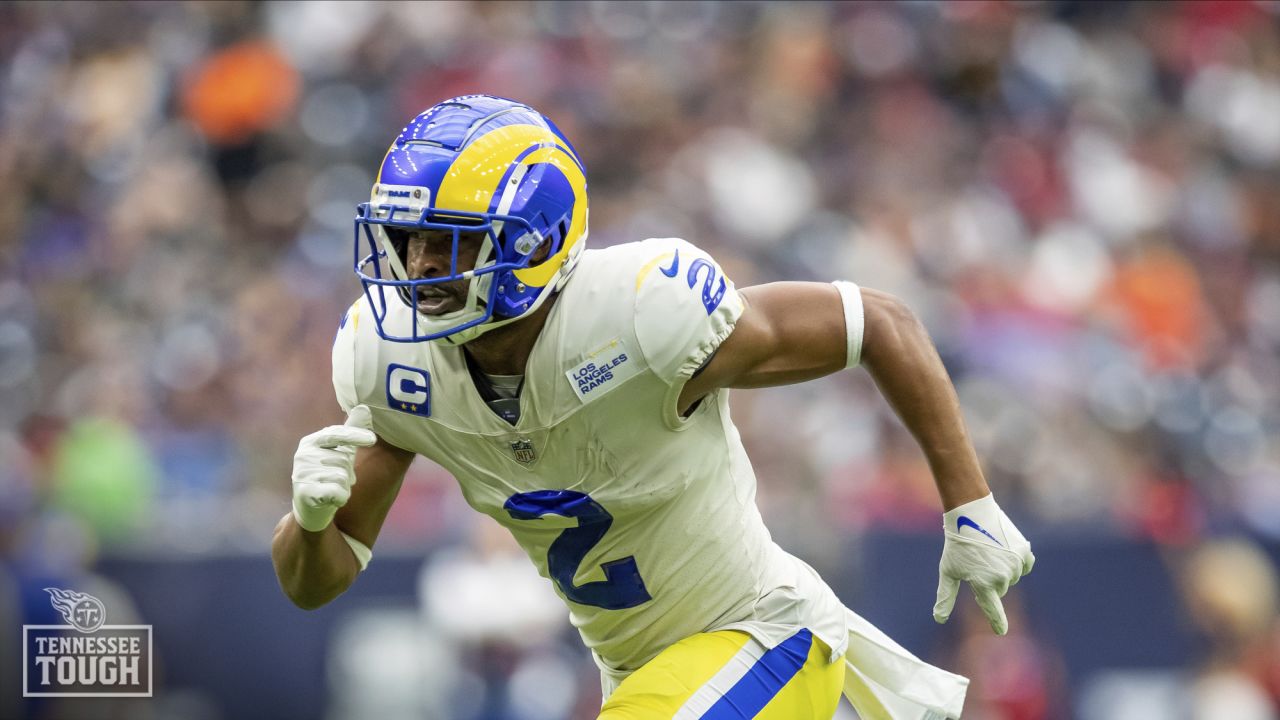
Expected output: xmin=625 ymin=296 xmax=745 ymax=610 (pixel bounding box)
xmin=678 ymin=282 xmax=1036 ymax=634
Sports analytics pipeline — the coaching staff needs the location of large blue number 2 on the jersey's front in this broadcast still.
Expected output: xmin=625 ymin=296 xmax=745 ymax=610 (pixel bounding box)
xmin=503 ymin=489 xmax=653 ymax=610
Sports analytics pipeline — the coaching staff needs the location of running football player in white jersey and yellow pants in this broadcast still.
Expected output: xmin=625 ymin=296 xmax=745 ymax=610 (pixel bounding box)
xmin=273 ymin=95 xmax=1034 ymax=720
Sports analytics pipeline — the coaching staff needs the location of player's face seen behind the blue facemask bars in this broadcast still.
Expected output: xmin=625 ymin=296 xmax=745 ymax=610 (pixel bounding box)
xmin=387 ymin=229 xmax=484 ymax=315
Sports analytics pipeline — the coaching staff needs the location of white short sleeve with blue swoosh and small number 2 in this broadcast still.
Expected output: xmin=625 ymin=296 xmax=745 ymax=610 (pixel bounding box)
xmin=635 ymin=238 xmax=744 ymax=418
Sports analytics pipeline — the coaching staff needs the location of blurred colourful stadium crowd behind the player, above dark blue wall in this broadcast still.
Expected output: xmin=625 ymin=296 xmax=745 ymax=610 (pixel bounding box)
xmin=0 ymin=1 xmax=1280 ymax=720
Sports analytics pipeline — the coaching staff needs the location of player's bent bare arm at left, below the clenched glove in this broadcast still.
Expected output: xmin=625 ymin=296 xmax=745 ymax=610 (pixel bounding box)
xmin=271 ymin=427 xmax=413 ymax=610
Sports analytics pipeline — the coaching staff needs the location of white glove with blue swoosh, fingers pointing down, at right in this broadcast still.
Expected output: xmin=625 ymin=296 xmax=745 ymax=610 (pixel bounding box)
xmin=933 ymin=495 xmax=1036 ymax=635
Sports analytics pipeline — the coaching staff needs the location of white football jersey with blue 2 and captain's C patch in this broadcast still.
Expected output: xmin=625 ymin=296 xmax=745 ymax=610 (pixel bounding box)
xmin=333 ymin=238 xmax=847 ymax=676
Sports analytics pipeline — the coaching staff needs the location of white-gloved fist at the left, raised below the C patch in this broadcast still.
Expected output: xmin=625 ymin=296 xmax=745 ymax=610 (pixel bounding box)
xmin=293 ymin=405 xmax=378 ymax=533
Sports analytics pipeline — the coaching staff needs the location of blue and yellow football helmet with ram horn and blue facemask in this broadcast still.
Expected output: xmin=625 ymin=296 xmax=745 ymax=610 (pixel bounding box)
xmin=355 ymin=95 xmax=588 ymax=345
